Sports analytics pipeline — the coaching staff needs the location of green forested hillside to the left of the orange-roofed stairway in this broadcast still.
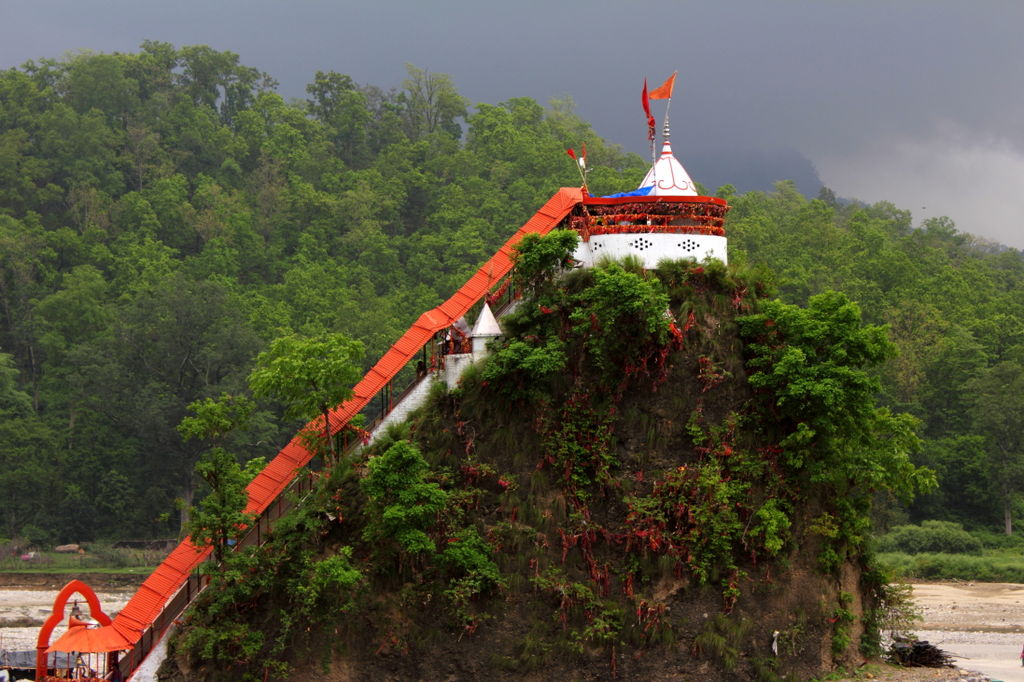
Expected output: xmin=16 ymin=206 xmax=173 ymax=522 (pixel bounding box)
xmin=0 ymin=41 xmax=645 ymax=546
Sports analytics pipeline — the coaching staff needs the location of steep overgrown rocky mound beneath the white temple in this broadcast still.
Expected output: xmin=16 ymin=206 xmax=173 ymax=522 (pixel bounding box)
xmin=164 ymin=256 xmax=925 ymax=680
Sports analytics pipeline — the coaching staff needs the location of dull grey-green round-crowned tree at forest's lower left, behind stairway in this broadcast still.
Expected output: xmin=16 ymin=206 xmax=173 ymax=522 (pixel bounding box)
xmin=76 ymin=270 xmax=259 ymax=527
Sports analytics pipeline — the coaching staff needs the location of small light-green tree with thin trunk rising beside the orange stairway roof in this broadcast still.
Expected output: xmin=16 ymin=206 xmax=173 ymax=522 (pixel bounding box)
xmin=249 ymin=333 xmax=362 ymax=461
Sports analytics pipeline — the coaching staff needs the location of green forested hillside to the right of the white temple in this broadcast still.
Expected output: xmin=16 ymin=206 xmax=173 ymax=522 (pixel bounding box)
xmin=727 ymin=184 xmax=1024 ymax=529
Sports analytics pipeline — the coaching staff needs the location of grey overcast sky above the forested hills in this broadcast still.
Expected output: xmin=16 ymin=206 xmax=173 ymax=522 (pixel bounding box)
xmin=0 ymin=0 xmax=1024 ymax=248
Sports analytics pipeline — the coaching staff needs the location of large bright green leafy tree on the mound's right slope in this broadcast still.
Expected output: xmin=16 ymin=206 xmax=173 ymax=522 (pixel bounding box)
xmin=738 ymin=292 xmax=935 ymax=566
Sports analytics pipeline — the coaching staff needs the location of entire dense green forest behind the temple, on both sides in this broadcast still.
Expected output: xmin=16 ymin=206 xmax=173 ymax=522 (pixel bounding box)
xmin=0 ymin=42 xmax=1024 ymax=543
